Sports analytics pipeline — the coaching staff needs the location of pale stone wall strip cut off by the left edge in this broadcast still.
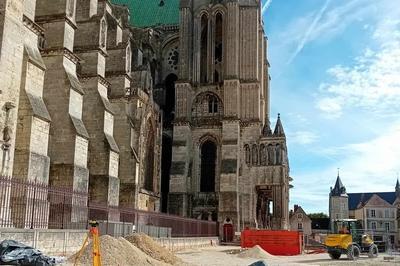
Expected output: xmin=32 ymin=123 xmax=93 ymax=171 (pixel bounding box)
xmin=0 ymin=0 xmax=25 ymax=179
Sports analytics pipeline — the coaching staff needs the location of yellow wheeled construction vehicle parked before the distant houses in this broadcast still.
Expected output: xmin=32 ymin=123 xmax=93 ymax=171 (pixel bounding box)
xmin=325 ymin=219 xmax=378 ymax=260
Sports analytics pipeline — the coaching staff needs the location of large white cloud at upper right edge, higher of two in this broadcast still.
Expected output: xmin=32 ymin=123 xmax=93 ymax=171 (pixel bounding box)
xmin=316 ymin=19 xmax=400 ymax=118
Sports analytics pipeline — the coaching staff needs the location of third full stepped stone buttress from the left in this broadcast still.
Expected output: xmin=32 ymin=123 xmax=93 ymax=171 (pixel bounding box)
xmin=74 ymin=4 xmax=119 ymax=221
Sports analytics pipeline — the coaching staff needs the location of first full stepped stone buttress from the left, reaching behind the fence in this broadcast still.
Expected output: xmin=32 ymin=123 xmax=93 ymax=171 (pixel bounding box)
xmin=11 ymin=1 xmax=50 ymax=228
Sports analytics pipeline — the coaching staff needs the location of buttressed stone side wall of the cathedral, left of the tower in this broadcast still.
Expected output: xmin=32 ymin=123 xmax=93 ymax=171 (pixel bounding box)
xmin=0 ymin=0 xmax=161 ymax=228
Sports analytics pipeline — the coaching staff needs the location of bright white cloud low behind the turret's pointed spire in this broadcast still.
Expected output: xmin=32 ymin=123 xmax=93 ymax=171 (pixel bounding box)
xmin=292 ymin=120 xmax=400 ymax=211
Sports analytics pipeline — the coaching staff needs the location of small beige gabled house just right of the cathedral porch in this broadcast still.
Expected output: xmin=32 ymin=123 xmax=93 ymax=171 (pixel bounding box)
xmin=289 ymin=205 xmax=312 ymax=244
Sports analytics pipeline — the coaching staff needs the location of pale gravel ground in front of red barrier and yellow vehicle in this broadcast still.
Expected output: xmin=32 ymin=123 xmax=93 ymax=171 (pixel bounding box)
xmin=176 ymin=246 xmax=400 ymax=266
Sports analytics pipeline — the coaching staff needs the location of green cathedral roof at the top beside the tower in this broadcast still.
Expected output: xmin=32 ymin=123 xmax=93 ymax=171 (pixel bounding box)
xmin=111 ymin=0 xmax=179 ymax=28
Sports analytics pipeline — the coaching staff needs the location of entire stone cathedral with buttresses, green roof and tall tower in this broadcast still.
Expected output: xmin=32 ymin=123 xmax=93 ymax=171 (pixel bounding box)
xmin=0 ymin=0 xmax=291 ymax=230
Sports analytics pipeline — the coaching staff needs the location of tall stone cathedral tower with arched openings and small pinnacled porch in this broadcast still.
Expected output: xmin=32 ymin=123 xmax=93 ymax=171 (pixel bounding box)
xmin=168 ymin=0 xmax=291 ymax=230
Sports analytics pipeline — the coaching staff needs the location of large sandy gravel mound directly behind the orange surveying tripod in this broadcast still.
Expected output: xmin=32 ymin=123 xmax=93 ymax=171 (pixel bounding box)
xmin=68 ymin=235 xmax=167 ymax=266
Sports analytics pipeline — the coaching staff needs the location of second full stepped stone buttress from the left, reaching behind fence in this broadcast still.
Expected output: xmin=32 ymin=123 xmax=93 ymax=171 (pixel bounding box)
xmin=36 ymin=0 xmax=89 ymax=228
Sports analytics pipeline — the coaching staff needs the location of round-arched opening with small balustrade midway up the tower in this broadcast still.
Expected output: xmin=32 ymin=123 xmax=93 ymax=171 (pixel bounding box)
xmin=192 ymin=91 xmax=224 ymax=118
